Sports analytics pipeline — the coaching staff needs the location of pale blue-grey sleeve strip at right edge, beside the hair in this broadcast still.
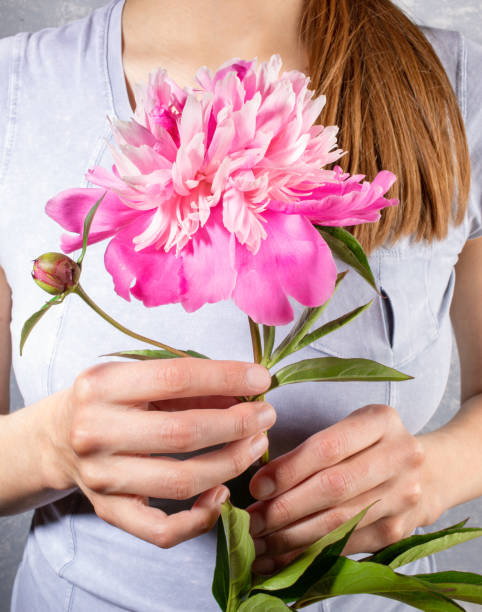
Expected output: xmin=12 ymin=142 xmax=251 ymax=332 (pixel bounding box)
xmin=460 ymin=32 xmax=482 ymax=239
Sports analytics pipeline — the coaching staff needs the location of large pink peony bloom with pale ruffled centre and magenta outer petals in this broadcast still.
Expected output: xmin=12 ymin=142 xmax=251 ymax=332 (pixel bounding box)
xmin=47 ymin=55 xmax=396 ymax=325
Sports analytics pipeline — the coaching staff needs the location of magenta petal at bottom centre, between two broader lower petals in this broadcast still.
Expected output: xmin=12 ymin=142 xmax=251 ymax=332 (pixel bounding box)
xmin=180 ymin=207 xmax=236 ymax=312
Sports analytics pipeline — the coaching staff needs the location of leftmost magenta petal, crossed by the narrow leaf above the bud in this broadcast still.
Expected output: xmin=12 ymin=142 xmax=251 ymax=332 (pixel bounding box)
xmin=45 ymin=188 xmax=140 ymax=252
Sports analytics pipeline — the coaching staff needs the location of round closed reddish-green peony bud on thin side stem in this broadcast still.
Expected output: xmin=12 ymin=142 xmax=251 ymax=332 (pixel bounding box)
xmin=32 ymin=253 xmax=80 ymax=295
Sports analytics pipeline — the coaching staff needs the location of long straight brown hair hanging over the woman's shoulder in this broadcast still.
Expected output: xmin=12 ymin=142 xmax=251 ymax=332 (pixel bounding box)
xmin=299 ymin=0 xmax=470 ymax=252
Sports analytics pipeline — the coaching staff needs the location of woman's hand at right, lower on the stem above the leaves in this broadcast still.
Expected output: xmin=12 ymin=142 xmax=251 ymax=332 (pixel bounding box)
xmin=247 ymin=405 xmax=442 ymax=574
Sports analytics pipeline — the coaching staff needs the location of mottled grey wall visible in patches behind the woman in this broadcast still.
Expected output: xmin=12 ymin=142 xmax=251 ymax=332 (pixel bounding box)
xmin=0 ymin=0 xmax=482 ymax=612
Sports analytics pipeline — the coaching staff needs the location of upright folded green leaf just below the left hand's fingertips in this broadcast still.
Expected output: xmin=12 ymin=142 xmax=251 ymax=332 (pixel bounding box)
xmin=213 ymin=500 xmax=255 ymax=612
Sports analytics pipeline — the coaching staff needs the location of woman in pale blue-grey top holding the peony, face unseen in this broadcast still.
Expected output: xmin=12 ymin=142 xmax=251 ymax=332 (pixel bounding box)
xmin=0 ymin=0 xmax=482 ymax=612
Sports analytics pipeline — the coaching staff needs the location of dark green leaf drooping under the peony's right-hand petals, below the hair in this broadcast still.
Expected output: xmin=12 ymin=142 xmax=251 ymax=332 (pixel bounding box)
xmin=315 ymin=225 xmax=380 ymax=294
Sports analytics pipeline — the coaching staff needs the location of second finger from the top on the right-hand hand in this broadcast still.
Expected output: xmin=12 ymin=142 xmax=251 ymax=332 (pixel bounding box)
xmin=247 ymin=443 xmax=399 ymax=535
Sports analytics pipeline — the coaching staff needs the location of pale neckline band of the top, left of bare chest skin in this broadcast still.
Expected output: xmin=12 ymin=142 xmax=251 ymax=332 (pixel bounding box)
xmin=106 ymin=0 xmax=134 ymax=121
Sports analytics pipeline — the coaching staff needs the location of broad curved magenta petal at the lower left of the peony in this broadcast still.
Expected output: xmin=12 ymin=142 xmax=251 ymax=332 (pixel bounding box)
xmin=104 ymin=213 xmax=182 ymax=306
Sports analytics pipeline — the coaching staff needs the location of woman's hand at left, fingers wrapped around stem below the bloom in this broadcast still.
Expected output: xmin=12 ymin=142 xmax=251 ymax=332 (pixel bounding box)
xmin=45 ymin=358 xmax=276 ymax=548
